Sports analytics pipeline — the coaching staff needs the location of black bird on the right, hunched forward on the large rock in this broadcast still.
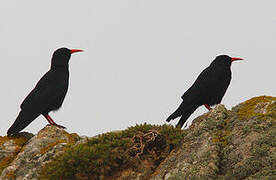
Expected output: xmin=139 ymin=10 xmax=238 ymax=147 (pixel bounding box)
xmin=166 ymin=55 xmax=242 ymax=128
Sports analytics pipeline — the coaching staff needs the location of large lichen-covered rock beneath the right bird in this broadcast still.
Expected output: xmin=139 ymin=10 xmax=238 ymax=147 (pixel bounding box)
xmin=152 ymin=96 xmax=276 ymax=180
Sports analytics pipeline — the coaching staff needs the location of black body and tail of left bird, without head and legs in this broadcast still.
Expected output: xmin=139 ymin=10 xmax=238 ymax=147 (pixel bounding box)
xmin=7 ymin=71 xmax=69 ymax=135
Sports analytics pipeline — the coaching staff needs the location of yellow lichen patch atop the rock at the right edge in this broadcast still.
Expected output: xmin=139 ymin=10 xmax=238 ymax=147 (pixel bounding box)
xmin=238 ymin=96 xmax=276 ymax=119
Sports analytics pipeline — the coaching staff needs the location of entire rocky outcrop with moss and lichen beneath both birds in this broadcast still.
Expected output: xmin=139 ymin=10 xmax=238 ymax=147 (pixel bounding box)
xmin=0 ymin=96 xmax=276 ymax=180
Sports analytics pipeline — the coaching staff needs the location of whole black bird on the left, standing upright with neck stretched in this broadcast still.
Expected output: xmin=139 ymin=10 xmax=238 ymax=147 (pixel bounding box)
xmin=7 ymin=48 xmax=82 ymax=136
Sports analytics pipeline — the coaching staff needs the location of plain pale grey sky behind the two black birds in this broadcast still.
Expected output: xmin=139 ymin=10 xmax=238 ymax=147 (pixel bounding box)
xmin=0 ymin=0 xmax=276 ymax=136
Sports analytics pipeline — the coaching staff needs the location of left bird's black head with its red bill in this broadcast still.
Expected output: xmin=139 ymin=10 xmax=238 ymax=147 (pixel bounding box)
xmin=52 ymin=48 xmax=83 ymax=67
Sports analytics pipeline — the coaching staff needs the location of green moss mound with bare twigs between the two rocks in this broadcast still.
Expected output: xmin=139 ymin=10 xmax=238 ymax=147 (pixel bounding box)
xmin=38 ymin=124 xmax=185 ymax=179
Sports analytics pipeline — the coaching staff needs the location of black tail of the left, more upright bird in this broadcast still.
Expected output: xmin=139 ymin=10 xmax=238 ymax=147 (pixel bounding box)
xmin=7 ymin=111 xmax=39 ymax=136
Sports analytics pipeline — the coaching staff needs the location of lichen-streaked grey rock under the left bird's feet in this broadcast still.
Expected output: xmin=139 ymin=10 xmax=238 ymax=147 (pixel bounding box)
xmin=0 ymin=126 xmax=81 ymax=180
